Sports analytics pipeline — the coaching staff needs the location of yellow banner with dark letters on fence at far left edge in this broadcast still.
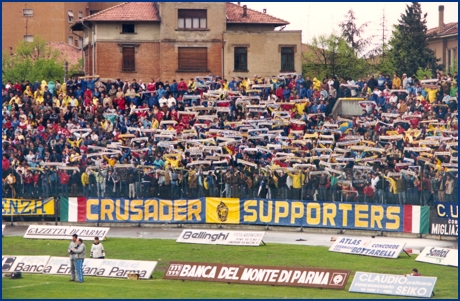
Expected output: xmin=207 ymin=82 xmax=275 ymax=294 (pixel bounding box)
xmin=2 ymin=198 xmax=54 ymax=216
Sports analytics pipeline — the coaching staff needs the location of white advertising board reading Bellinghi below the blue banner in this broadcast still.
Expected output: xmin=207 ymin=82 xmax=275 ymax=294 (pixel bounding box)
xmin=176 ymin=230 xmax=265 ymax=246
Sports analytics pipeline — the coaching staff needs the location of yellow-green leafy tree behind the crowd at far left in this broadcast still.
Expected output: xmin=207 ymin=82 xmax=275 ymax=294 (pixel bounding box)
xmin=2 ymin=36 xmax=64 ymax=82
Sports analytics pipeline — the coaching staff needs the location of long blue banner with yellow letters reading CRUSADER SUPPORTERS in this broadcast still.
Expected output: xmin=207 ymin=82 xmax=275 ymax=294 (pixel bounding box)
xmin=86 ymin=198 xmax=404 ymax=232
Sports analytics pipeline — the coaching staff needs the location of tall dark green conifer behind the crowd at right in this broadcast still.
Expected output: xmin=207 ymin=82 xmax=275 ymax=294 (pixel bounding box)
xmin=389 ymin=2 xmax=437 ymax=76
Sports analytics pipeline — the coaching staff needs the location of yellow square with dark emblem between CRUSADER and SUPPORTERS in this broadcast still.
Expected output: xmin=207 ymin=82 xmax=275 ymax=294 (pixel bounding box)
xmin=206 ymin=198 xmax=240 ymax=224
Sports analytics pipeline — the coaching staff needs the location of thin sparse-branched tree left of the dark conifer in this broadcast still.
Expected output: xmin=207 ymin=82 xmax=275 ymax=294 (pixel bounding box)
xmin=339 ymin=9 xmax=372 ymax=56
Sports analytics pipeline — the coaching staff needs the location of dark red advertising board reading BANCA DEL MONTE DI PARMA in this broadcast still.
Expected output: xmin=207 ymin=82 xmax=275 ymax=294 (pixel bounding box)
xmin=163 ymin=262 xmax=350 ymax=289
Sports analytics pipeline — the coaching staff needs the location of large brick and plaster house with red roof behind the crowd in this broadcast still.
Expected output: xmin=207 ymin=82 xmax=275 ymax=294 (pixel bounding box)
xmin=72 ymin=2 xmax=302 ymax=81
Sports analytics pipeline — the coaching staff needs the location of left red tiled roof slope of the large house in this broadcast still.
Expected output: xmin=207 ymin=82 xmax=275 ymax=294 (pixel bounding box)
xmin=76 ymin=2 xmax=160 ymax=23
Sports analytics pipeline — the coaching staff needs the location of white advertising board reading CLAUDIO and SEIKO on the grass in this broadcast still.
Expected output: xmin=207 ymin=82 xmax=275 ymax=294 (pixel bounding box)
xmin=349 ymin=272 xmax=437 ymax=298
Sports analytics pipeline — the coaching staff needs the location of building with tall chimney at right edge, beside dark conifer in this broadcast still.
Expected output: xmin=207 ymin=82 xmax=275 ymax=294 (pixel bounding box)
xmin=427 ymin=5 xmax=458 ymax=71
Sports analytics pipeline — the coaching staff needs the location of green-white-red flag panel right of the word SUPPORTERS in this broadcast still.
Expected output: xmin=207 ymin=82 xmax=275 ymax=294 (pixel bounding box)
xmin=404 ymin=205 xmax=430 ymax=234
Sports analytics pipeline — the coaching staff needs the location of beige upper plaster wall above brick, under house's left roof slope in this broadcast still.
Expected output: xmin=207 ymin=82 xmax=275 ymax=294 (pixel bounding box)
xmin=95 ymin=22 xmax=160 ymax=42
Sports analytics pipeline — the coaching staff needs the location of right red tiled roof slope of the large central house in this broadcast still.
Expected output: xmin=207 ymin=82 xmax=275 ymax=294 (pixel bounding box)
xmin=227 ymin=3 xmax=289 ymax=26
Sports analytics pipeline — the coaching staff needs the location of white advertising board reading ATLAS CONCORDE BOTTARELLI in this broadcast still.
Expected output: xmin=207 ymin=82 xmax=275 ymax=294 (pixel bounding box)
xmin=329 ymin=237 xmax=406 ymax=258
